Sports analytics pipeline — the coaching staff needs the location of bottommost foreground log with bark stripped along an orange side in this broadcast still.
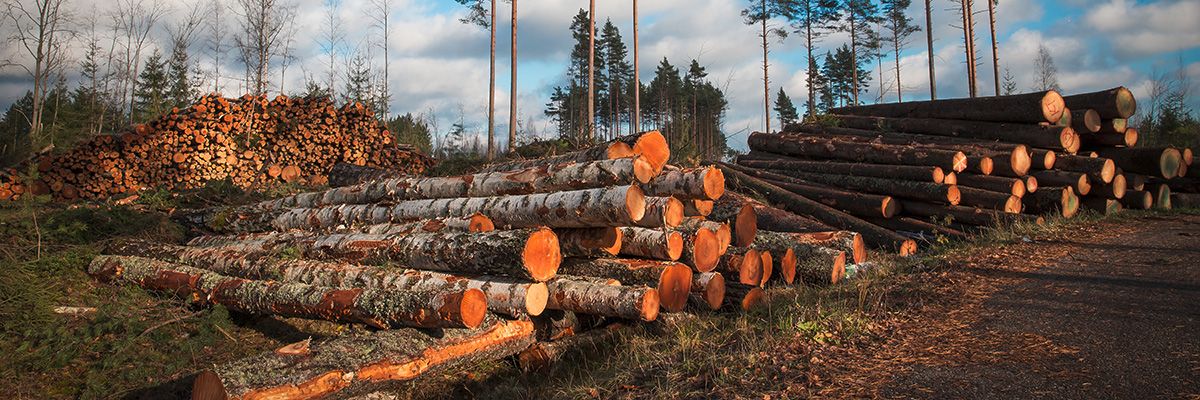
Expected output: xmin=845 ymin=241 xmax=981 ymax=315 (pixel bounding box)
xmin=192 ymin=318 xmax=535 ymax=399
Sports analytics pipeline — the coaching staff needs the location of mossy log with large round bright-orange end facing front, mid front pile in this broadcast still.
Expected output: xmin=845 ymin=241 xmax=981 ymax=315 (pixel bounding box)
xmin=188 ymin=228 xmax=562 ymax=281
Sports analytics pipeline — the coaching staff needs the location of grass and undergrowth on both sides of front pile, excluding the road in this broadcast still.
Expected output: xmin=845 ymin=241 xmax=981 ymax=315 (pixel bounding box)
xmin=0 ymin=184 xmax=1200 ymax=399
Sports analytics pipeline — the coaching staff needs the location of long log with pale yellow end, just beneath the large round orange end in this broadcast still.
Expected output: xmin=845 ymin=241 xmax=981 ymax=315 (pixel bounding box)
xmin=107 ymin=240 xmax=546 ymax=317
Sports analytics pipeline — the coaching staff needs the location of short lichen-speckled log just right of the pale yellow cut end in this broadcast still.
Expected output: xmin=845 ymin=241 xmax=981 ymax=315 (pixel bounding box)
xmin=546 ymin=276 xmax=660 ymax=321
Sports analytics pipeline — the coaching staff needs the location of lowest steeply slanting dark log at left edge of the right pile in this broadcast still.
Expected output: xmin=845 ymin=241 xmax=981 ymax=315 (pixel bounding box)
xmin=721 ymin=165 xmax=917 ymax=256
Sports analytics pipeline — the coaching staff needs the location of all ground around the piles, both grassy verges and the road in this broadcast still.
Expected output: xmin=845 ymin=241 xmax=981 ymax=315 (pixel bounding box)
xmin=0 ymin=182 xmax=1200 ymax=399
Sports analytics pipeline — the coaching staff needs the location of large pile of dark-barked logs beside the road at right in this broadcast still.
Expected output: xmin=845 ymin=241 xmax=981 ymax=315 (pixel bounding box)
xmin=721 ymin=88 xmax=1200 ymax=253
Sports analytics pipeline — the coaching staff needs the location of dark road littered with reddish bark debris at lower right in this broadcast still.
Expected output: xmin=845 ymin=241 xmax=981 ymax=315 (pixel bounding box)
xmin=815 ymin=215 xmax=1200 ymax=399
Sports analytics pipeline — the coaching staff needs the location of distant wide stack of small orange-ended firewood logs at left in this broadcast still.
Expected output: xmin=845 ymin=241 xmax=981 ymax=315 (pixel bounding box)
xmin=0 ymin=95 xmax=432 ymax=201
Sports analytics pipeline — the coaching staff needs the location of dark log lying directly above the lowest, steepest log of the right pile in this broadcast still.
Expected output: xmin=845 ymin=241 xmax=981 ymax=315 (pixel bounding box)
xmin=715 ymin=166 xmax=899 ymax=217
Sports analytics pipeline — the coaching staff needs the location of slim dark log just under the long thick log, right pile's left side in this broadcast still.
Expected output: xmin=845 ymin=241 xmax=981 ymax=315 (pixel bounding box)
xmin=737 ymin=151 xmax=946 ymax=184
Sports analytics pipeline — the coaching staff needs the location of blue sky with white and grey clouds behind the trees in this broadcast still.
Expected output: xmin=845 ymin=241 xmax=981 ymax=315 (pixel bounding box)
xmin=0 ymin=0 xmax=1200 ymax=149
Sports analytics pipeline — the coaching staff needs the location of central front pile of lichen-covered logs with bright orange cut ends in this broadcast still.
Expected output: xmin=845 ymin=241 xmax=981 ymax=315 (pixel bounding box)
xmin=89 ymin=131 xmax=866 ymax=398
